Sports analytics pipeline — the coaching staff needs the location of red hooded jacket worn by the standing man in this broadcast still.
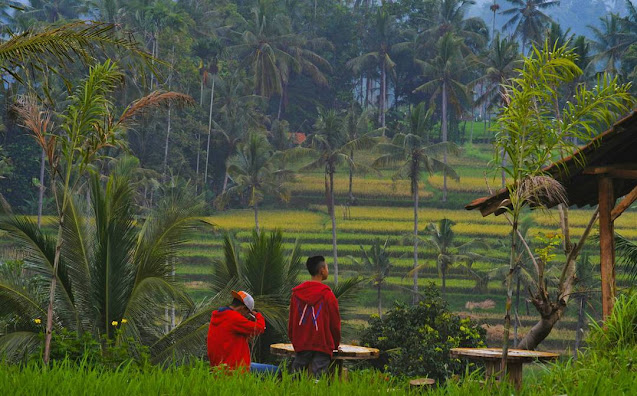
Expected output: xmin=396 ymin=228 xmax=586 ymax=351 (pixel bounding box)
xmin=288 ymin=281 xmax=341 ymax=356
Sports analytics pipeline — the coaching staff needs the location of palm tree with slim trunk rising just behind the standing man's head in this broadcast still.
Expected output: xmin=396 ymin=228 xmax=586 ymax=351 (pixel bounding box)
xmin=294 ymin=108 xmax=376 ymax=285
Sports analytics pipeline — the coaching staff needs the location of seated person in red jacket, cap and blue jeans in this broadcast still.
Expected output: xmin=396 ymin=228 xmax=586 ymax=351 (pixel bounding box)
xmin=207 ymin=291 xmax=278 ymax=373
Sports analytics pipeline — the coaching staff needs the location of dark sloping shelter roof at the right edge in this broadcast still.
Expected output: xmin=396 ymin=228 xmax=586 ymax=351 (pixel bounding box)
xmin=465 ymin=109 xmax=637 ymax=216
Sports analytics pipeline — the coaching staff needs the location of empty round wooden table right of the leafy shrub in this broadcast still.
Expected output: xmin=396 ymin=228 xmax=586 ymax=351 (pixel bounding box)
xmin=450 ymin=348 xmax=560 ymax=389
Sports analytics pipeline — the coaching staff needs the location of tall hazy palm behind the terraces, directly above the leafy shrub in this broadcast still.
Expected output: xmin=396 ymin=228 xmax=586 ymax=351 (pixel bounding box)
xmin=415 ymin=33 xmax=469 ymax=202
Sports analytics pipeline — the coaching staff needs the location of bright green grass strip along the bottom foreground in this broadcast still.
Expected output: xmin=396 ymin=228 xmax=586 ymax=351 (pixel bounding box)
xmin=0 ymin=347 xmax=637 ymax=396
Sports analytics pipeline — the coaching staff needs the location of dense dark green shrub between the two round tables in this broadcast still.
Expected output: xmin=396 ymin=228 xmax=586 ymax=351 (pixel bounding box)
xmin=361 ymin=285 xmax=486 ymax=380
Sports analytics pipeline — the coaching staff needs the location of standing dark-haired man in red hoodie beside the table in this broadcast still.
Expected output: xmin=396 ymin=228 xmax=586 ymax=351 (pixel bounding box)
xmin=288 ymin=256 xmax=341 ymax=377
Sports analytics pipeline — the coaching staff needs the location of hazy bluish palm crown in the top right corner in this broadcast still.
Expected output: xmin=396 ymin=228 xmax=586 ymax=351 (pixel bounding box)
xmin=588 ymin=13 xmax=632 ymax=76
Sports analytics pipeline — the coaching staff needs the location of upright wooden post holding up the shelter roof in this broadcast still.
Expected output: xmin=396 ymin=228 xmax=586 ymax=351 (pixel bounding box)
xmin=598 ymin=176 xmax=615 ymax=320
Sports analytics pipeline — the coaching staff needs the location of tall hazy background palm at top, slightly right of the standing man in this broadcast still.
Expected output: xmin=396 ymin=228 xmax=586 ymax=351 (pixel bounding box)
xmin=347 ymin=5 xmax=397 ymax=130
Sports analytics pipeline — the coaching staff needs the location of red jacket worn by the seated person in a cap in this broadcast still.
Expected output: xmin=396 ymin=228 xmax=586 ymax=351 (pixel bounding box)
xmin=207 ymin=307 xmax=265 ymax=369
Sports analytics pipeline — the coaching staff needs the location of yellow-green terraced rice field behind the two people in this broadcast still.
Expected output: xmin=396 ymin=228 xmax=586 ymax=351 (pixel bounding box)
xmin=0 ymin=146 xmax=637 ymax=350
